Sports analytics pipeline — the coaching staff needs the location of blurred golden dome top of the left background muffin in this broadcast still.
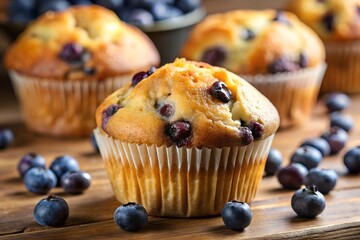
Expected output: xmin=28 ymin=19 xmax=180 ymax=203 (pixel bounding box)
xmin=5 ymin=5 xmax=159 ymax=80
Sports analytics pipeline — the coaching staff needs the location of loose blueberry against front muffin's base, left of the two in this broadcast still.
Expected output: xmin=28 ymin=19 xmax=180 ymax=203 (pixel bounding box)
xmin=114 ymin=202 xmax=148 ymax=231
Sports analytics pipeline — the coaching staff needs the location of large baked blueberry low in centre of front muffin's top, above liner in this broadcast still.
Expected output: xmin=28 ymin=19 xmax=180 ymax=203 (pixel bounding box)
xmin=165 ymin=121 xmax=191 ymax=147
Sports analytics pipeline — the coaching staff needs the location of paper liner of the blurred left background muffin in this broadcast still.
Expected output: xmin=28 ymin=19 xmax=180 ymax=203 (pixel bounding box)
xmin=9 ymin=71 xmax=133 ymax=137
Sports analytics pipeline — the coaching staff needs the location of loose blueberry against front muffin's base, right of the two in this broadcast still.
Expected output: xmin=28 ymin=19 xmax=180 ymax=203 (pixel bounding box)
xmin=221 ymin=200 xmax=252 ymax=231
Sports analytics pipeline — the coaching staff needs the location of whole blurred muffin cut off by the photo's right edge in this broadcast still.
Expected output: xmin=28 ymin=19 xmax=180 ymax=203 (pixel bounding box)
xmin=288 ymin=0 xmax=360 ymax=93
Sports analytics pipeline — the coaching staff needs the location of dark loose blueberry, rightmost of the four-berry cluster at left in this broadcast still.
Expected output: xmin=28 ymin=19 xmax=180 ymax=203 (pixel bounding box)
xmin=60 ymin=171 xmax=91 ymax=194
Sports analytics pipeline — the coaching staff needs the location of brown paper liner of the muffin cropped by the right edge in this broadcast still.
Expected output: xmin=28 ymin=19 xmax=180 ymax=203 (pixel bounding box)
xmin=321 ymin=41 xmax=360 ymax=93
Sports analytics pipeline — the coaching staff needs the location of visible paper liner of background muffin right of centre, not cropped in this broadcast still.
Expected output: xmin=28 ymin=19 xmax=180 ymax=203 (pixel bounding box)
xmin=240 ymin=63 xmax=327 ymax=128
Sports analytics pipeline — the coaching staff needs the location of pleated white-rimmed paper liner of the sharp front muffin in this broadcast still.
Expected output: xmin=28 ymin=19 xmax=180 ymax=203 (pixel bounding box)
xmin=94 ymin=129 xmax=274 ymax=217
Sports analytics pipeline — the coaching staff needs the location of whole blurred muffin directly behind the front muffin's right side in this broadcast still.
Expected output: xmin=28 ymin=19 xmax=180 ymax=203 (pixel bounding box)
xmin=182 ymin=10 xmax=326 ymax=128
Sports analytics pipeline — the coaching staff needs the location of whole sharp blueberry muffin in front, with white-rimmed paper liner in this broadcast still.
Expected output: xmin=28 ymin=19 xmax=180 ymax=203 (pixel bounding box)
xmin=95 ymin=59 xmax=279 ymax=217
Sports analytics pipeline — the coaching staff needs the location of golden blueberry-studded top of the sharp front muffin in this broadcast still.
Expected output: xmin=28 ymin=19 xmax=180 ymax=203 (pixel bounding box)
xmin=96 ymin=59 xmax=279 ymax=148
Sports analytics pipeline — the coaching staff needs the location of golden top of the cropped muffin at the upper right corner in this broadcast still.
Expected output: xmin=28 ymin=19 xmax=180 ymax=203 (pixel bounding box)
xmin=289 ymin=0 xmax=360 ymax=41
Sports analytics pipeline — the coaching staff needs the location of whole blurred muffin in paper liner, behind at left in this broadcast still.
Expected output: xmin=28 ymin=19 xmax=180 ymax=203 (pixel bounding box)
xmin=5 ymin=5 xmax=160 ymax=137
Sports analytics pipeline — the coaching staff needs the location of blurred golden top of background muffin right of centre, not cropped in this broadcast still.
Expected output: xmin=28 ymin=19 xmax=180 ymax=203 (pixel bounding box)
xmin=182 ymin=10 xmax=325 ymax=74
